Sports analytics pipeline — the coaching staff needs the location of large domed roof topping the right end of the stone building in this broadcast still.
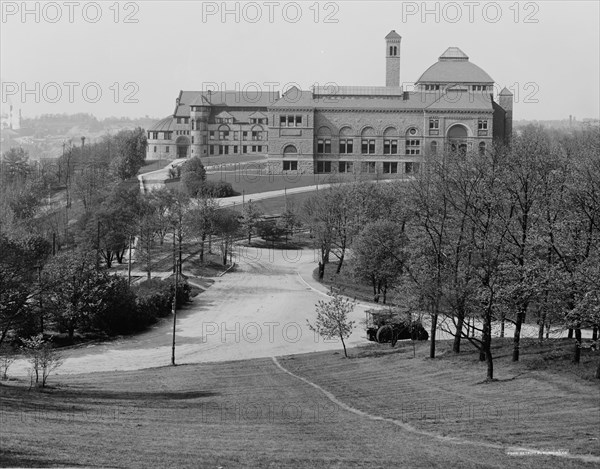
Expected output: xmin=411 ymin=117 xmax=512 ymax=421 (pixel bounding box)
xmin=417 ymin=47 xmax=494 ymax=83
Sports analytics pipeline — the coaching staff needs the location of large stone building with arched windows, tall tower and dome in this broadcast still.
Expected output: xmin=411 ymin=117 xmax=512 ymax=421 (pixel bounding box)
xmin=148 ymin=31 xmax=513 ymax=174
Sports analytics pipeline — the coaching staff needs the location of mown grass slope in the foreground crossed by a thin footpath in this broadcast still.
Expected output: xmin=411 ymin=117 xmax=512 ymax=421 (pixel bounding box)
xmin=0 ymin=338 xmax=600 ymax=468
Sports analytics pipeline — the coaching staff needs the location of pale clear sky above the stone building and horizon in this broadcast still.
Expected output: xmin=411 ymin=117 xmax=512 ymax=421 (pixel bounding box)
xmin=0 ymin=0 xmax=600 ymax=120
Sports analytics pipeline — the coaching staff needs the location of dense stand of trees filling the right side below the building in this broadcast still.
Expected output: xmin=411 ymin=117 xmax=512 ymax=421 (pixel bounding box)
xmin=302 ymin=126 xmax=600 ymax=379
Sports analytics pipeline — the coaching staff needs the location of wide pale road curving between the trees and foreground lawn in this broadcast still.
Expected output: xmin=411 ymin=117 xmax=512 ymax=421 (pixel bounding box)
xmin=10 ymin=247 xmax=366 ymax=375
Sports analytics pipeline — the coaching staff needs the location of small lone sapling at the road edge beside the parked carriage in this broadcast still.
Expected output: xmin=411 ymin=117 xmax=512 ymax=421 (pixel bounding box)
xmin=306 ymin=291 xmax=354 ymax=358
